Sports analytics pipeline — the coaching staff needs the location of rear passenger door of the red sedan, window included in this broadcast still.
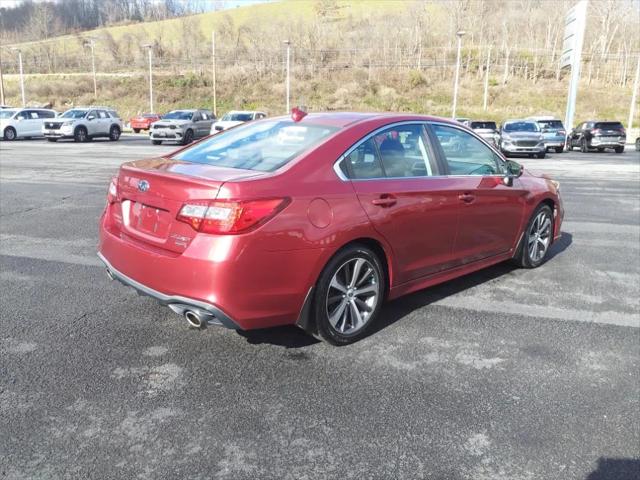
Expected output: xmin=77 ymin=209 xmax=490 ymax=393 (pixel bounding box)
xmin=341 ymin=123 xmax=458 ymax=284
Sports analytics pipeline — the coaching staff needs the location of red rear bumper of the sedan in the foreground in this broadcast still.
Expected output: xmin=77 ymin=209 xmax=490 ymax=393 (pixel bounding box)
xmin=99 ymin=214 xmax=326 ymax=330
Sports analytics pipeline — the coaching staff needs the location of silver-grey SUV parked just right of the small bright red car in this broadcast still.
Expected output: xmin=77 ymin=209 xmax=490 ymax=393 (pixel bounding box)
xmin=149 ymin=109 xmax=216 ymax=145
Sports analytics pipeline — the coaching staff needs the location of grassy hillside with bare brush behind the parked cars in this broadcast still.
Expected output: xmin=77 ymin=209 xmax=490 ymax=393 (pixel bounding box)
xmin=3 ymin=0 xmax=640 ymax=124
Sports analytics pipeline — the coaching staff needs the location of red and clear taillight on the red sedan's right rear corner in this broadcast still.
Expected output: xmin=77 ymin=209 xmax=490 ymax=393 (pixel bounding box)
xmin=177 ymin=198 xmax=289 ymax=234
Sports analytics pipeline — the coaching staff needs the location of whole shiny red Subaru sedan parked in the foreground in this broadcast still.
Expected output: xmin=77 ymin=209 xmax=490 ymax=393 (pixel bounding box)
xmin=99 ymin=111 xmax=564 ymax=345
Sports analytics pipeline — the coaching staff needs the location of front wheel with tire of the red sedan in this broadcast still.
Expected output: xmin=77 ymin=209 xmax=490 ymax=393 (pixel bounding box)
xmin=514 ymin=204 xmax=554 ymax=268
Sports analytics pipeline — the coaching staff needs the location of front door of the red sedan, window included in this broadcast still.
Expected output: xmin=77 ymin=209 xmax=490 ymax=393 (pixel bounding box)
xmin=430 ymin=122 xmax=527 ymax=264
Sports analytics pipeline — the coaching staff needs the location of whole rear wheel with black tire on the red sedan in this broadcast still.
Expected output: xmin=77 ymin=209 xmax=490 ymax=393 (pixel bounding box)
xmin=313 ymin=245 xmax=386 ymax=345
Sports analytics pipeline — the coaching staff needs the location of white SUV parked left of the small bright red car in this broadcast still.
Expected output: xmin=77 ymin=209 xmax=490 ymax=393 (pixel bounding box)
xmin=42 ymin=107 xmax=122 ymax=142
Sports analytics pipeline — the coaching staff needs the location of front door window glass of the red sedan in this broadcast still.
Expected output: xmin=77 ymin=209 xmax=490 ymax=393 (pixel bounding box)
xmin=432 ymin=125 xmax=504 ymax=175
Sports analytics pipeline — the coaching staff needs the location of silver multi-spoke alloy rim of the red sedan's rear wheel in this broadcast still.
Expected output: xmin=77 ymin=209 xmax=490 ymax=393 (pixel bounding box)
xmin=326 ymin=257 xmax=381 ymax=335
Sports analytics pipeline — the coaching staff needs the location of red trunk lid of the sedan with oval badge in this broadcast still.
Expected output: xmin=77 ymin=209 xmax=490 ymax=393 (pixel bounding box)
xmin=112 ymin=158 xmax=260 ymax=254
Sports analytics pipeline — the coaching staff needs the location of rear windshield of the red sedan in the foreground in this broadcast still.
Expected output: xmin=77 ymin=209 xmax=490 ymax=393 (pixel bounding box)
xmin=173 ymin=120 xmax=337 ymax=172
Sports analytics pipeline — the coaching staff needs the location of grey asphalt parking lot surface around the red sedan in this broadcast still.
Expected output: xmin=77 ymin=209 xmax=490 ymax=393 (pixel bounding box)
xmin=0 ymin=135 xmax=640 ymax=480
